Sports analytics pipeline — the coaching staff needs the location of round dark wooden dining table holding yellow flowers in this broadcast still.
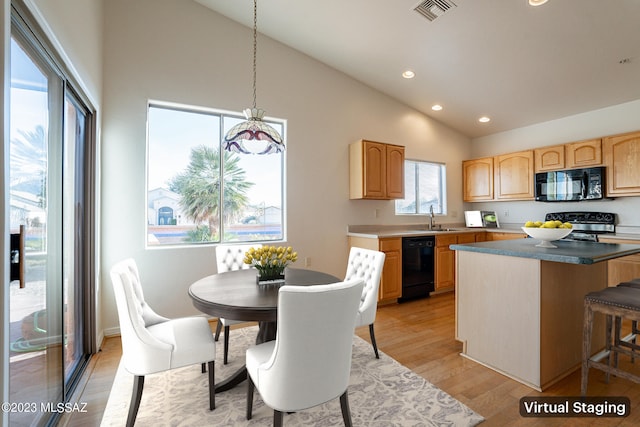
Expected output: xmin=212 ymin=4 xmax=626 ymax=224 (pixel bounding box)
xmin=189 ymin=268 xmax=342 ymax=392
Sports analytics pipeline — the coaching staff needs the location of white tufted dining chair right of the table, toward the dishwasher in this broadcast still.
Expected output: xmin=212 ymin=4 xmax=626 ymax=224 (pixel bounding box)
xmin=344 ymin=247 xmax=385 ymax=359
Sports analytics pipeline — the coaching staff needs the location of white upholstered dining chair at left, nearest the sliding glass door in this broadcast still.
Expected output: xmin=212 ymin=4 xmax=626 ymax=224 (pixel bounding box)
xmin=111 ymin=259 xmax=216 ymax=426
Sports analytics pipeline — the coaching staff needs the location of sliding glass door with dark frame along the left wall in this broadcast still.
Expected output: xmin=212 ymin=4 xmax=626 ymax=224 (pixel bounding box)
xmin=9 ymin=5 xmax=92 ymax=426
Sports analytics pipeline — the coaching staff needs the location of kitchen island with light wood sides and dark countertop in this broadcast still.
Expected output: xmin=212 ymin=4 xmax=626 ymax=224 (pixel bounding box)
xmin=451 ymin=239 xmax=640 ymax=391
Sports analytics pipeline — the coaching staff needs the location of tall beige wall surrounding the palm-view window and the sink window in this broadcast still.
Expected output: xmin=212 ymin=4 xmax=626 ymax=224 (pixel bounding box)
xmin=102 ymin=0 xmax=470 ymax=334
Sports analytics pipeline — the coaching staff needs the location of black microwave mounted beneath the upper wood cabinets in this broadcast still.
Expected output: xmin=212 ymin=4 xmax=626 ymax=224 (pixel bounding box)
xmin=535 ymin=167 xmax=606 ymax=202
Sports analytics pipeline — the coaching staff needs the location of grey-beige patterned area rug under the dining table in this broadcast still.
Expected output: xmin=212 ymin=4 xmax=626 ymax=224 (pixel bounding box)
xmin=101 ymin=326 xmax=484 ymax=427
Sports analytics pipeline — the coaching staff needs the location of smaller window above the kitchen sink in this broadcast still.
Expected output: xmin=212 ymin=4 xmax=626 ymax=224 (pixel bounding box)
xmin=396 ymin=160 xmax=447 ymax=215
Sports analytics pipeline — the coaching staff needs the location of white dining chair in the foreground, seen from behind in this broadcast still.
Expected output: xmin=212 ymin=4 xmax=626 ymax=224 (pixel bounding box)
xmin=247 ymin=279 xmax=364 ymax=426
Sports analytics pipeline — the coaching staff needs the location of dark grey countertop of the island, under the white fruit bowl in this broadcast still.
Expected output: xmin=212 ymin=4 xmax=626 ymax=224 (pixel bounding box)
xmin=449 ymin=239 xmax=640 ymax=264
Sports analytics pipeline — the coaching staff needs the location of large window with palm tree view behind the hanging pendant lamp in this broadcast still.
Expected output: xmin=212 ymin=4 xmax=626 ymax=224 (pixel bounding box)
xmin=147 ymin=103 xmax=285 ymax=246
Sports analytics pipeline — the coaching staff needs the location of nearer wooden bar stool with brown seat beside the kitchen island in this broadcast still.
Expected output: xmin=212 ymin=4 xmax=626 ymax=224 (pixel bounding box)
xmin=581 ymin=286 xmax=640 ymax=396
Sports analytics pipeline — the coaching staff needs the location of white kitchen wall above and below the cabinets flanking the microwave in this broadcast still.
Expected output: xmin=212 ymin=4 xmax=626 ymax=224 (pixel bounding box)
xmin=465 ymin=100 xmax=640 ymax=230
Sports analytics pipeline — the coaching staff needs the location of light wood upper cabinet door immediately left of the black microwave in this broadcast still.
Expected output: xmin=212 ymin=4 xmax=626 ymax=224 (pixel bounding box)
xmin=493 ymin=150 xmax=534 ymax=200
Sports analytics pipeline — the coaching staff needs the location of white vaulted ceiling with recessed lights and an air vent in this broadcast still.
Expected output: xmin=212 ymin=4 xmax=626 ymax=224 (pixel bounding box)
xmin=195 ymin=0 xmax=640 ymax=138
